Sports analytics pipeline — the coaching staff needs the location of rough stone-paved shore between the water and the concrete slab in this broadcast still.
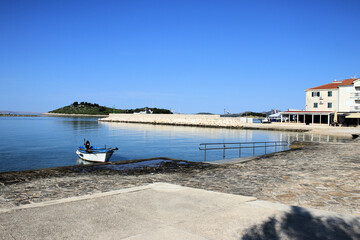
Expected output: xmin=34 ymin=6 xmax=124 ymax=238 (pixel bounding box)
xmin=0 ymin=140 xmax=360 ymax=215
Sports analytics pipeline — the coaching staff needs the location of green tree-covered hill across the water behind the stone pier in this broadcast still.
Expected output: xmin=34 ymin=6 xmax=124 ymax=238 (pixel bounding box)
xmin=49 ymin=102 xmax=172 ymax=115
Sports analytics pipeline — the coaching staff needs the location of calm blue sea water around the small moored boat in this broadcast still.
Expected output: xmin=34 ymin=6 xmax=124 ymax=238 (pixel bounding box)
xmin=0 ymin=117 xmax=348 ymax=172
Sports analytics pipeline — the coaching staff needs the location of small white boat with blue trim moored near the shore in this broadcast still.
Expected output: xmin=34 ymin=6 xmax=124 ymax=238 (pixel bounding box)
xmin=76 ymin=141 xmax=118 ymax=162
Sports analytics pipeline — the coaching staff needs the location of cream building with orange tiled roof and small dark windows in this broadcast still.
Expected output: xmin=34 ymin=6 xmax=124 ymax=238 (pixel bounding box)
xmin=305 ymin=78 xmax=360 ymax=113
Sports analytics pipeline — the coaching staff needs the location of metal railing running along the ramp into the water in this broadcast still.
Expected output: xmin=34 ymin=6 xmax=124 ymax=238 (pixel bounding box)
xmin=199 ymin=141 xmax=289 ymax=161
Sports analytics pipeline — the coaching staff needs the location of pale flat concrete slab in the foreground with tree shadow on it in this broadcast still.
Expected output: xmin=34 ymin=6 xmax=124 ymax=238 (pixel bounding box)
xmin=0 ymin=183 xmax=360 ymax=240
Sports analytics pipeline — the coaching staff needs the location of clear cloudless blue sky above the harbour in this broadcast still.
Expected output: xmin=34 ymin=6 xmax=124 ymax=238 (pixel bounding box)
xmin=0 ymin=0 xmax=360 ymax=113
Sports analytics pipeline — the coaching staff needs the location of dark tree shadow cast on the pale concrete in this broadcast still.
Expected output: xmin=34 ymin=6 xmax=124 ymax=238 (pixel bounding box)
xmin=241 ymin=207 xmax=360 ymax=240
